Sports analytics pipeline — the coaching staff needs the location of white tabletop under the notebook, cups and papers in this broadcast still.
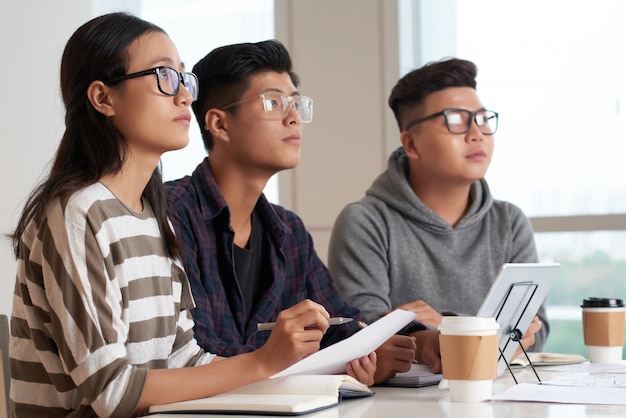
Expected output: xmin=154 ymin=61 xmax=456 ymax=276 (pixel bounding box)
xmin=152 ymin=368 xmax=626 ymax=418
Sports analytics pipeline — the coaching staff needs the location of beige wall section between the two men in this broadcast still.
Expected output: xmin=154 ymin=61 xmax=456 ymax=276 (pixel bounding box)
xmin=276 ymin=0 xmax=400 ymax=260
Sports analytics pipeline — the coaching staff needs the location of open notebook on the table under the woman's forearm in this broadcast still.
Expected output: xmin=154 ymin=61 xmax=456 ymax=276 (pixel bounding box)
xmin=149 ymin=375 xmax=374 ymax=415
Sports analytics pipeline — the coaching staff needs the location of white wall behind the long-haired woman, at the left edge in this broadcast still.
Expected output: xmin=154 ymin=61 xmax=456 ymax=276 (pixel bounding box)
xmin=0 ymin=0 xmax=91 ymax=314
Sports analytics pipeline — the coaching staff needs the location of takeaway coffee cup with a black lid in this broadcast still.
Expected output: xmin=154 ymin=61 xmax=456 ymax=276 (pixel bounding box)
xmin=581 ymin=298 xmax=626 ymax=363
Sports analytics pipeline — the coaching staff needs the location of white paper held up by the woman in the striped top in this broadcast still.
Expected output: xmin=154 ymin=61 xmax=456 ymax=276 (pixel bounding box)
xmin=271 ymin=309 xmax=417 ymax=378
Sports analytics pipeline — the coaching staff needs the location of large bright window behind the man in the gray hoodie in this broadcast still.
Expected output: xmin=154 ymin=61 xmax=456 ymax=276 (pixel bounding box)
xmin=401 ymin=0 xmax=626 ymax=354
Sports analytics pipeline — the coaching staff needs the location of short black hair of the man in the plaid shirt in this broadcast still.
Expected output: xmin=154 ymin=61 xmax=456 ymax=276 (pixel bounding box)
xmin=191 ymin=39 xmax=300 ymax=151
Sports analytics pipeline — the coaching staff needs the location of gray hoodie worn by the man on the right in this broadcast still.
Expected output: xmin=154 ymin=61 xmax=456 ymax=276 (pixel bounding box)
xmin=328 ymin=148 xmax=549 ymax=351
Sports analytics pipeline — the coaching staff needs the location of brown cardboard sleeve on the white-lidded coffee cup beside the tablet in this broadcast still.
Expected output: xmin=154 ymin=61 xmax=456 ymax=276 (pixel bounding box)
xmin=439 ymin=334 xmax=498 ymax=380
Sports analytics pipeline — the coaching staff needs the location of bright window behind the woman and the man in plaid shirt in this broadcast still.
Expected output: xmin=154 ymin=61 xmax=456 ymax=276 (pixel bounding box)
xmin=92 ymin=0 xmax=278 ymax=202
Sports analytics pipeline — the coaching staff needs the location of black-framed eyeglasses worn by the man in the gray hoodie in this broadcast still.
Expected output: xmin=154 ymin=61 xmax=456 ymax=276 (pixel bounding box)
xmin=404 ymin=109 xmax=498 ymax=135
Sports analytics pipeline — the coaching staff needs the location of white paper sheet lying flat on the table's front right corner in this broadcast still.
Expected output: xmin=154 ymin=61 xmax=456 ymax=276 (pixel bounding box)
xmin=491 ymin=383 xmax=626 ymax=405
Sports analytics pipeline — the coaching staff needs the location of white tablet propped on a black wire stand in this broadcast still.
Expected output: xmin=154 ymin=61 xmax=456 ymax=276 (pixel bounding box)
xmin=476 ymin=263 xmax=561 ymax=375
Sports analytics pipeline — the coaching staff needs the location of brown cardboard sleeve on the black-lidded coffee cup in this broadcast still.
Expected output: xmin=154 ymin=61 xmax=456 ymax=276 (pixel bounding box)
xmin=584 ymin=309 xmax=624 ymax=346
